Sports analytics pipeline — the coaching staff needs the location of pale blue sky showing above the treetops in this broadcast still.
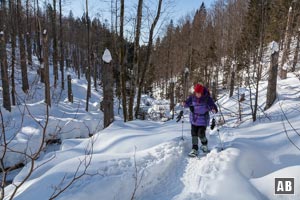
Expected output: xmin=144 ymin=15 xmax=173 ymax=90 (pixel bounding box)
xmin=59 ymin=0 xmax=216 ymax=43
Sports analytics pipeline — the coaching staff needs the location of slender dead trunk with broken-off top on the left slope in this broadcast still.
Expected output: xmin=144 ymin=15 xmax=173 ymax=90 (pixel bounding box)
xmin=43 ymin=29 xmax=51 ymax=107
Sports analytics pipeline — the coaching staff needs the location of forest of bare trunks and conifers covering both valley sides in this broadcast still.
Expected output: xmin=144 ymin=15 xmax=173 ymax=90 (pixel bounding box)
xmin=0 ymin=0 xmax=300 ymax=121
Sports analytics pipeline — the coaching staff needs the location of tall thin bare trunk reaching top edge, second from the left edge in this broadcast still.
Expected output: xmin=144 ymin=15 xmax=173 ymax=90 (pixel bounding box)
xmin=9 ymin=0 xmax=16 ymax=106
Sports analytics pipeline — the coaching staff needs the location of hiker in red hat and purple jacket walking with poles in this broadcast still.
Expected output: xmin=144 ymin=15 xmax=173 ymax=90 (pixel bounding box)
xmin=183 ymin=84 xmax=218 ymax=157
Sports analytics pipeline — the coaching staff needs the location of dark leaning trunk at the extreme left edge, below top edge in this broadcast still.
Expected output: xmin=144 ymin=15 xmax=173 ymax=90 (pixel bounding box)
xmin=0 ymin=32 xmax=11 ymax=112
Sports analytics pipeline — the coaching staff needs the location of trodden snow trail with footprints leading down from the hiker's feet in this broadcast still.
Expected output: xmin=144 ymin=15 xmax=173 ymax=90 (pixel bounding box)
xmin=137 ymin=131 xmax=235 ymax=200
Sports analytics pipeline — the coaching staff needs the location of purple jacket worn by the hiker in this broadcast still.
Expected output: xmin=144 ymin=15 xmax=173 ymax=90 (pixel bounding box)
xmin=184 ymin=88 xmax=218 ymax=126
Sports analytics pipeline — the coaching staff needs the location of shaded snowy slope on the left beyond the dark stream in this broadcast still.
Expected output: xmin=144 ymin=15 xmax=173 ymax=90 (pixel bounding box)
xmin=0 ymin=52 xmax=103 ymax=167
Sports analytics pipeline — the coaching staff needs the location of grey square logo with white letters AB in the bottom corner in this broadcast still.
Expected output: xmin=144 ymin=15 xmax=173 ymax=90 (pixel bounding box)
xmin=275 ymin=178 xmax=295 ymax=194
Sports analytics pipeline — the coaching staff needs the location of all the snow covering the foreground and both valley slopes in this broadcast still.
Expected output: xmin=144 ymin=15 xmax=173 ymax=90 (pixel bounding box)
xmin=1 ymin=28 xmax=300 ymax=200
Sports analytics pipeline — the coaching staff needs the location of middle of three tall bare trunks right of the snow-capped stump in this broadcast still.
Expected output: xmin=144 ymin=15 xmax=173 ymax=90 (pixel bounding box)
xmin=128 ymin=0 xmax=143 ymax=121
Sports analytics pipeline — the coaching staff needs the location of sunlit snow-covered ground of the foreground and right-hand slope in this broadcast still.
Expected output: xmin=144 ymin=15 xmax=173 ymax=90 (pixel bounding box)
xmin=5 ymin=74 xmax=300 ymax=200
